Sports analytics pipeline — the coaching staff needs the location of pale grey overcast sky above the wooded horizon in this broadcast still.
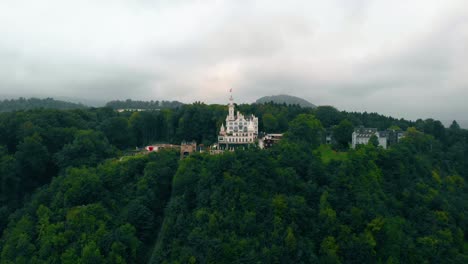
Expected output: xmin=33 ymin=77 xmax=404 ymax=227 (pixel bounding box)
xmin=0 ymin=0 xmax=468 ymax=119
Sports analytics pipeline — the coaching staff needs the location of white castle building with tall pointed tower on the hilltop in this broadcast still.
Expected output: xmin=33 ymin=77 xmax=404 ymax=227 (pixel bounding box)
xmin=218 ymin=94 xmax=258 ymax=150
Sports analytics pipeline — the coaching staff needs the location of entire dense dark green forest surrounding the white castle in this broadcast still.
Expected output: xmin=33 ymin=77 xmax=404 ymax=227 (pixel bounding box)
xmin=0 ymin=103 xmax=468 ymax=264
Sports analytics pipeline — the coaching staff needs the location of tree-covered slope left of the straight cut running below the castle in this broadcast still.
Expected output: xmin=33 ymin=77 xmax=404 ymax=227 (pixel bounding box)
xmin=0 ymin=151 xmax=178 ymax=263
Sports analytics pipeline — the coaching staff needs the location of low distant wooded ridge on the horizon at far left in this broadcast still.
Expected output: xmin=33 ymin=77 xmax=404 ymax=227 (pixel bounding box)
xmin=0 ymin=97 xmax=87 ymax=112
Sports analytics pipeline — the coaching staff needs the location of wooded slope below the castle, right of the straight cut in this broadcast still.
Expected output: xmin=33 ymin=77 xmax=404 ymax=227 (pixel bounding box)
xmin=151 ymin=124 xmax=467 ymax=263
